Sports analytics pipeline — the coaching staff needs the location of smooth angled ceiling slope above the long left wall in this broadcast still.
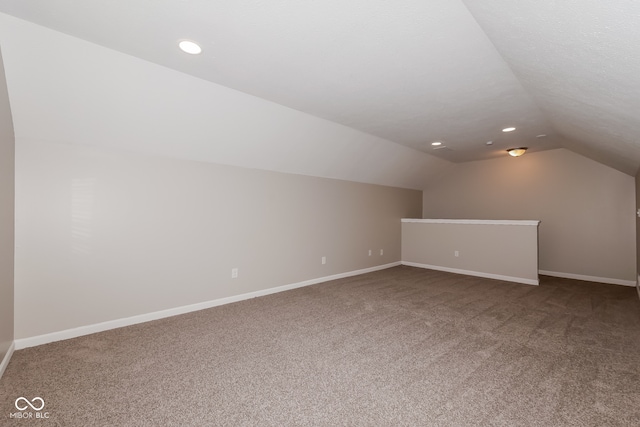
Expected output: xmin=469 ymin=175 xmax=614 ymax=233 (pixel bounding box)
xmin=0 ymin=13 xmax=451 ymax=189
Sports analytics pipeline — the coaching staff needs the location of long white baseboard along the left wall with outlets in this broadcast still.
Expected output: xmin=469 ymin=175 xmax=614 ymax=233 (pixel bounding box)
xmin=15 ymin=262 xmax=400 ymax=350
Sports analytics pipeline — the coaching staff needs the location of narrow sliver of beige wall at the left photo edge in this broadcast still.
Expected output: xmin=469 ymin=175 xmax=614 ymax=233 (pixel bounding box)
xmin=0 ymin=47 xmax=15 ymax=362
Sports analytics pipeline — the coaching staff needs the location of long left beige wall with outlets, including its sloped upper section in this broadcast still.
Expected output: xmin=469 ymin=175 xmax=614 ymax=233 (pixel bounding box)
xmin=0 ymin=14 xmax=432 ymax=344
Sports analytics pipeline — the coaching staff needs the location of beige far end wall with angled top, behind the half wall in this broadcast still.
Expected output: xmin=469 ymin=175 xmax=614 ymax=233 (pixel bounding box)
xmin=423 ymin=149 xmax=636 ymax=282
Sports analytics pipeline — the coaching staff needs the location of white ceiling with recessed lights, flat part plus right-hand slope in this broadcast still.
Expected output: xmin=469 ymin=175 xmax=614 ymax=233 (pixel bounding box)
xmin=0 ymin=0 xmax=640 ymax=174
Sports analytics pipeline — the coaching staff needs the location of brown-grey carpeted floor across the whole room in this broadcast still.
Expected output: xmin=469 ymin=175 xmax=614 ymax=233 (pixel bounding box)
xmin=0 ymin=267 xmax=640 ymax=427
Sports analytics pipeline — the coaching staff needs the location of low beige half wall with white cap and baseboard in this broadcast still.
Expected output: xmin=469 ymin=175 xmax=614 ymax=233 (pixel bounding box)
xmin=402 ymin=221 xmax=538 ymax=285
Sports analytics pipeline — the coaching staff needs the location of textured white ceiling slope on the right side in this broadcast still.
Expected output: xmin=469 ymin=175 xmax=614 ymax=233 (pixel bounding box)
xmin=463 ymin=0 xmax=640 ymax=175
